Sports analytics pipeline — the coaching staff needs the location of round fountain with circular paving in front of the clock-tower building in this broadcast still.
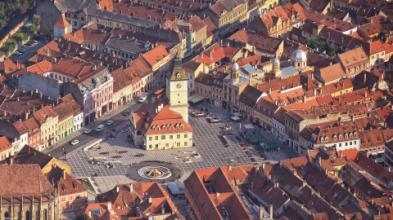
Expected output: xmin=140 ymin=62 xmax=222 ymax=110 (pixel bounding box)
xmin=127 ymin=161 xmax=181 ymax=183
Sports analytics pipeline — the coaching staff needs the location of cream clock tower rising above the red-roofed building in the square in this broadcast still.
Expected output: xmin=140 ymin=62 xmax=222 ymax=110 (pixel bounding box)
xmin=166 ymin=62 xmax=188 ymax=123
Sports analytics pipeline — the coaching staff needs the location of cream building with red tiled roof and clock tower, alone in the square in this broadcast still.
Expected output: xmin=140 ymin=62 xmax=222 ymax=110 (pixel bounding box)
xmin=130 ymin=64 xmax=193 ymax=150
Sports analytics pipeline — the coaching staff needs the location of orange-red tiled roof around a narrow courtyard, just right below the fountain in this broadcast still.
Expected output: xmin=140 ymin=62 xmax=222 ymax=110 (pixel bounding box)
xmin=184 ymin=166 xmax=251 ymax=219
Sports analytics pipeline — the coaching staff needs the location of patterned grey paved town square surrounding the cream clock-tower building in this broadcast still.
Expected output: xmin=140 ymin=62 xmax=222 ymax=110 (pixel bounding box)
xmin=62 ymin=103 xmax=294 ymax=192
